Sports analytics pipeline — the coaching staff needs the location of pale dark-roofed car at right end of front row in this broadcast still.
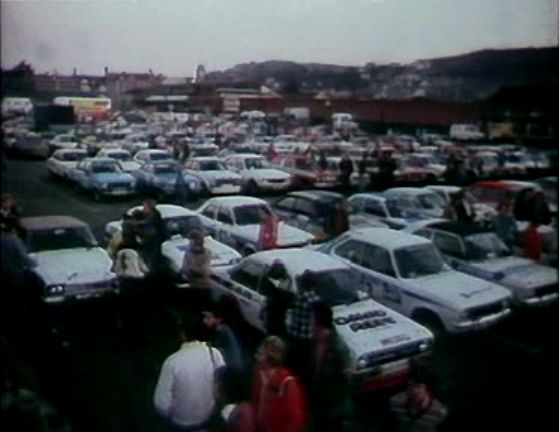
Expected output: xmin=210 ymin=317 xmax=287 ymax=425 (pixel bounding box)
xmin=406 ymin=221 xmax=559 ymax=306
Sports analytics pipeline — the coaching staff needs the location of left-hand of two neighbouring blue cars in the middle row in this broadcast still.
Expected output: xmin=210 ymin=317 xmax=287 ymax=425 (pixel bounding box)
xmin=68 ymin=158 xmax=136 ymax=201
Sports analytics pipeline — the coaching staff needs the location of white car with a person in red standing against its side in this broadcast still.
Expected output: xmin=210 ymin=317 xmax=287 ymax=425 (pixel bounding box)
xmin=196 ymin=195 xmax=315 ymax=255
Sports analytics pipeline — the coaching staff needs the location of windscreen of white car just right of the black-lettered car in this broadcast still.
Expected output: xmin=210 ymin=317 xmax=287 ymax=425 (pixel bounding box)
xmin=394 ymin=243 xmax=444 ymax=279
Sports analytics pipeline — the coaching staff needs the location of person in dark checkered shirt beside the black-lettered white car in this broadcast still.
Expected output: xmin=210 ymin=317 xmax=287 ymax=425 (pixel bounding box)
xmin=287 ymin=271 xmax=320 ymax=388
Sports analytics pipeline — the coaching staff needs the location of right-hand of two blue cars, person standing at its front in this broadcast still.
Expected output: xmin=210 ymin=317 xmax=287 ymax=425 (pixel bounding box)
xmin=133 ymin=161 xmax=202 ymax=199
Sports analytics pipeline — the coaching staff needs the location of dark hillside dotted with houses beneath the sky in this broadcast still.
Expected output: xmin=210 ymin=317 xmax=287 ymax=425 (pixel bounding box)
xmin=206 ymin=47 xmax=559 ymax=102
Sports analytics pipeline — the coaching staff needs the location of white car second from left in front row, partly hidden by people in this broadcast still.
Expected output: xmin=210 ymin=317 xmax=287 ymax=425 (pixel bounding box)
xmin=105 ymin=204 xmax=241 ymax=275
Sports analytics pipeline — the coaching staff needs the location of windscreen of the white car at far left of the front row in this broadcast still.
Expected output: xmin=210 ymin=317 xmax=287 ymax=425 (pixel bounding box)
xmin=26 ymin=227 xmax=97 ymax=252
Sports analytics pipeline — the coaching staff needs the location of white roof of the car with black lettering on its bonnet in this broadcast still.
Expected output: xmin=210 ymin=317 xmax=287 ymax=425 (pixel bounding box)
xmin=251 ymin=248 xmax=349 ymax=276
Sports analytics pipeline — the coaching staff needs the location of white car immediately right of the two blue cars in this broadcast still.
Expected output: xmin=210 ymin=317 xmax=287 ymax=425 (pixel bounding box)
xmin=184 ymin=156 xmax=243 ymax=195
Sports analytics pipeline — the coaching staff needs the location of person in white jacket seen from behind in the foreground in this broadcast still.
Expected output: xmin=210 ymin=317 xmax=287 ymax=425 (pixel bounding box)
xmin=153 ymin=315 xmax=225 ymax=432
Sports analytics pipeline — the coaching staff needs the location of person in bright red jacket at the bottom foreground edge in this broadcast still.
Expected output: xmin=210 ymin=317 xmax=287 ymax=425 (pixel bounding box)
xmin=252 ymin=336 xmax=307 ymax=432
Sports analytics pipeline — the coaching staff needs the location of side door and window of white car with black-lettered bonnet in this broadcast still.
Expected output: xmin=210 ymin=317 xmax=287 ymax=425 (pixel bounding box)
xmin=229 ymin=259 xmax=265 ymax=331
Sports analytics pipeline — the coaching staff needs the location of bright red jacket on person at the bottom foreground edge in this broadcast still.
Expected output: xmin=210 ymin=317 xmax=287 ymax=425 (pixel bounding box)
xmin=252 ymin=368 xmax=307 ymax=432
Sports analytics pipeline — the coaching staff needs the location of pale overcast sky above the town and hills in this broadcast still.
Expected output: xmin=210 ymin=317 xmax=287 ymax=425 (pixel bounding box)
xmin=1 ymin=0 xmax=558 ymax=76
